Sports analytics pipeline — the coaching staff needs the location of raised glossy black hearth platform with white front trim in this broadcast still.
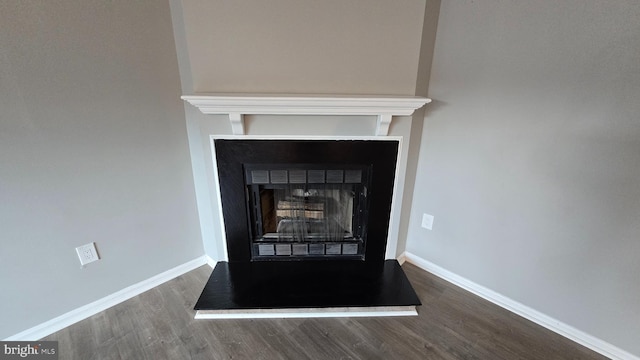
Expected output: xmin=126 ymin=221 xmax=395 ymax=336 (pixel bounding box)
xmin=195 ymin=260 xmax=420 ymax=319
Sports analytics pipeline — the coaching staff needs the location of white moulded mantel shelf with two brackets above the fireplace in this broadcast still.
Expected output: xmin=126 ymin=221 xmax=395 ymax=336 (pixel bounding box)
xmin=182 ymin=93 xmax=431 ymax=136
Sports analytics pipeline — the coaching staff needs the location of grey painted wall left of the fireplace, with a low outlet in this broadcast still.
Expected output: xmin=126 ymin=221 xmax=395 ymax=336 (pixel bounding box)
xmin=0 ymin=0 xmax=203 ymax=338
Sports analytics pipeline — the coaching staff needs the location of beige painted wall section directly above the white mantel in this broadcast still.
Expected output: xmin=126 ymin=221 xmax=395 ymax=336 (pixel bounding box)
xmin=182 ymin=0 xmax=425 ymax=95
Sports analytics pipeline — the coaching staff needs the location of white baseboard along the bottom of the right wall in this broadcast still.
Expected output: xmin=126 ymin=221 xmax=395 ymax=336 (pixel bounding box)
xmin=398 ymin=252 xmax=640 ymax=360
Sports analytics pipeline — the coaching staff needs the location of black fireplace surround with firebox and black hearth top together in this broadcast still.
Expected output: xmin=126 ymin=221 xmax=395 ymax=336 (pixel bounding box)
xmin=195 ymin=139 xmax=420 ymax=311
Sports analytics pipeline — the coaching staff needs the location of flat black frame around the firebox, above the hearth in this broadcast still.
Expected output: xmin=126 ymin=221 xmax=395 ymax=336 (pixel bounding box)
xmin=218 ymin=139 xmax=399 ymax=263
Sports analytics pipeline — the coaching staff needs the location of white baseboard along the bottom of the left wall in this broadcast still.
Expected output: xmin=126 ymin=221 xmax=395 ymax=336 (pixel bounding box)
xmin=4 ymin=256 xmax=209 ymax=341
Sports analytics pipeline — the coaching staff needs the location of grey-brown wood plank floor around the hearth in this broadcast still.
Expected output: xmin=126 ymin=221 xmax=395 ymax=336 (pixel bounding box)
xmin=44 ymin=263 xmax=606 ymax=360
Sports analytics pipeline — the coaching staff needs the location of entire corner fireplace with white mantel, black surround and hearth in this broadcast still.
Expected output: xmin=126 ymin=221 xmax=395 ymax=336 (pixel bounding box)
xmin=182 ymin=94 xmax=430 ymax=319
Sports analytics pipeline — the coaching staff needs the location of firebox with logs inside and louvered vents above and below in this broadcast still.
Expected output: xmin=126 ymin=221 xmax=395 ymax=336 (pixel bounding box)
xmin=244 ymin=164 xmax=371 ymax=260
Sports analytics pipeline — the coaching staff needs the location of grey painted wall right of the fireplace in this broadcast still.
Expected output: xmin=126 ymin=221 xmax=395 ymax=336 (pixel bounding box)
xmin=407 ymin=0 xmax=640 ymax=356
